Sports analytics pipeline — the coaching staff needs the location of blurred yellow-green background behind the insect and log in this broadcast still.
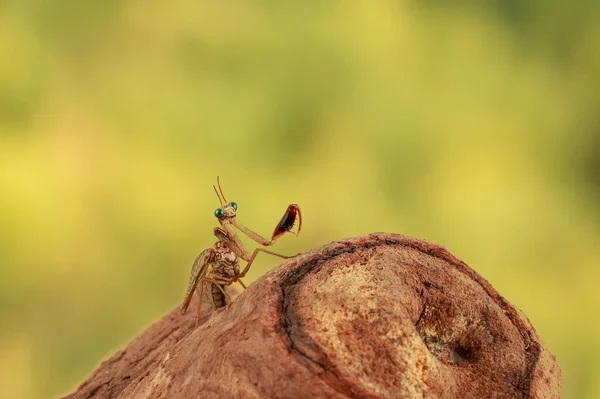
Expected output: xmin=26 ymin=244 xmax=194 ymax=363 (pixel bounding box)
xmin=0 ymin=0 xmax=600 ymax=399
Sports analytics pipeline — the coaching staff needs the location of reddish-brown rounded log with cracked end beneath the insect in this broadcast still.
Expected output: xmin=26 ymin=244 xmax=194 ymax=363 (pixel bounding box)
xmin=67 ymin=233 xmax=561 ymax=399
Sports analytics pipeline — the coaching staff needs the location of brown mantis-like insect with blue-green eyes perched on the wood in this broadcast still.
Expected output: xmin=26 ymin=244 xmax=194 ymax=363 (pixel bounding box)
xmin=181 ymin=176 xmax=302 ymax=328
